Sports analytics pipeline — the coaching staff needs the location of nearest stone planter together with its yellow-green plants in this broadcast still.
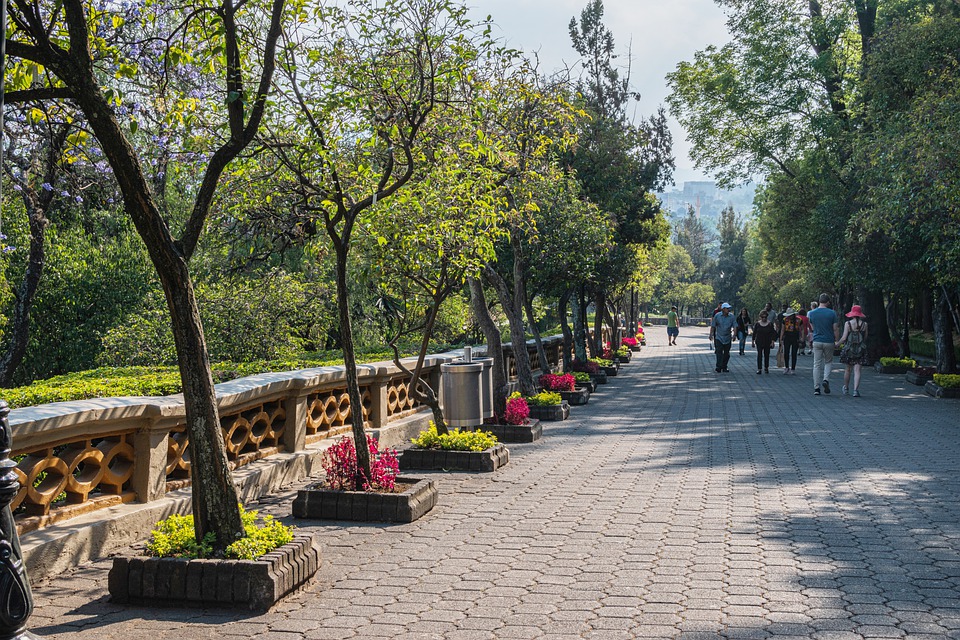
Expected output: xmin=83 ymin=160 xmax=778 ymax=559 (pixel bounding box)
xmin=107 ymin=507 xmax=320 ymax=611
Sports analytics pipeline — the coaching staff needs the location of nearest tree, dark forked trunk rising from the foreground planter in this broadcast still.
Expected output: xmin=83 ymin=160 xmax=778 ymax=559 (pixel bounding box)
xmin=6 ymin=0 xmax=285 ymax=551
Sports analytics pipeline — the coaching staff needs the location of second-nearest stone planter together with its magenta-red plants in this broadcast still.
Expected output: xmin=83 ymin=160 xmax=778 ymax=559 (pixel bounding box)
xmin=293 ymin=435 xmax=437 ymax=522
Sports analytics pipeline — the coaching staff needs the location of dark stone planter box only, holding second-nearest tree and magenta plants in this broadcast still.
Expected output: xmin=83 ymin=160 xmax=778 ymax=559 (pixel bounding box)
xmin=293 ymin=476 xmax=437 ymax=522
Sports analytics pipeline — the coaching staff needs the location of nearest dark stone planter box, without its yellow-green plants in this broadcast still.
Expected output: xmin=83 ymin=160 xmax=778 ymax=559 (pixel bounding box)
xmin=107 ymin=535 xmax=320 ymax=611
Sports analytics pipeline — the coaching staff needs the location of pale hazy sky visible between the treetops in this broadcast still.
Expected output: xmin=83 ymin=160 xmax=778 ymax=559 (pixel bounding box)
xmin=466 ymin=0 xmax=729 ymax=186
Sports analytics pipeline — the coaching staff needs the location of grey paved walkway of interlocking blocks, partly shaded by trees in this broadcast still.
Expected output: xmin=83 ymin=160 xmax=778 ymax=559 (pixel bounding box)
xmin=30 ymin=328 xmax=960 ymax=640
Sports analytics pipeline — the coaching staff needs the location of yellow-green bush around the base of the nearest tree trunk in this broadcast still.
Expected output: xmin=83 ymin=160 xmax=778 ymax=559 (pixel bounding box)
xmin=147 ymin=506 xmax=293 ymax=560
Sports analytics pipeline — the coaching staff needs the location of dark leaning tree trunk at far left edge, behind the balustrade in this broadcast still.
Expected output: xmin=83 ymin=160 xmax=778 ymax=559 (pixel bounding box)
xmin=0 ymin=194 xmax=50 ymax=387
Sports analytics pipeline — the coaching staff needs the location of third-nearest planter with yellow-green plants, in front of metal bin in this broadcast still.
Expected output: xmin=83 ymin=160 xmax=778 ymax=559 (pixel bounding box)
xmin=400 ymin=422 xmax=510 ymax=471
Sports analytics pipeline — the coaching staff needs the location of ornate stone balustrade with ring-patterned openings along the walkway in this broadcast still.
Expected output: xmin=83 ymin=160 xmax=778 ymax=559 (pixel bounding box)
xmin=10 ymin=337 xmax=562 ymax=532
